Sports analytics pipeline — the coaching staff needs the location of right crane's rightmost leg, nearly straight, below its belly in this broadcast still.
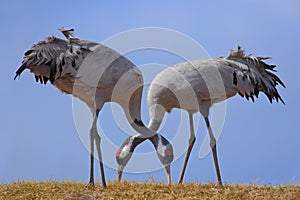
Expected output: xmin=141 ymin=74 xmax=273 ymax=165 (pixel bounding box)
xmin=205 ymin=117 xmax=222 ymax=186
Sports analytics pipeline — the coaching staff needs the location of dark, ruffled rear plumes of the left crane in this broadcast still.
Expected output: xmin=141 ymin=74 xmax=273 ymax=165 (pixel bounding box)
xmin=14 ymin=36 xmax=99 ymax=86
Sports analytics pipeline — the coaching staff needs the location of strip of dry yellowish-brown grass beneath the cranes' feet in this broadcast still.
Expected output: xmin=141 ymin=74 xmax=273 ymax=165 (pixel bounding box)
xmin=0 ymin=181 xmax=300 ymax=200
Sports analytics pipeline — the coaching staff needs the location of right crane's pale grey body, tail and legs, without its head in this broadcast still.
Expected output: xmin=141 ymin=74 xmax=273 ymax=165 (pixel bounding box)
xmin=116 ymin=46 xmax=285 ymax=185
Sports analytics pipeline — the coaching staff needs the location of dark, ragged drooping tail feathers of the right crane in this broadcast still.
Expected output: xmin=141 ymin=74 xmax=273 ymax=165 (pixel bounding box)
xmin=226 ymin=46 xmax=285 ymax=104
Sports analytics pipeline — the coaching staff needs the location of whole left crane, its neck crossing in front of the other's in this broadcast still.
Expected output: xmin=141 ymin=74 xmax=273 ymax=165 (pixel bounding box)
xmin=14 ymin=29 xmax=173 ymax=187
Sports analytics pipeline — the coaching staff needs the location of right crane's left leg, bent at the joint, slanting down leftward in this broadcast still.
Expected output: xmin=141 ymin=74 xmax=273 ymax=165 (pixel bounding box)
xmin=179 ymin=112 xmax=196 ymax=183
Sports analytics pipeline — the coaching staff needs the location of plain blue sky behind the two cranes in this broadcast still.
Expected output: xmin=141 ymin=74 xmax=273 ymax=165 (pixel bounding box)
xmin=0 ymin=0 xmax=300 ymax=184
